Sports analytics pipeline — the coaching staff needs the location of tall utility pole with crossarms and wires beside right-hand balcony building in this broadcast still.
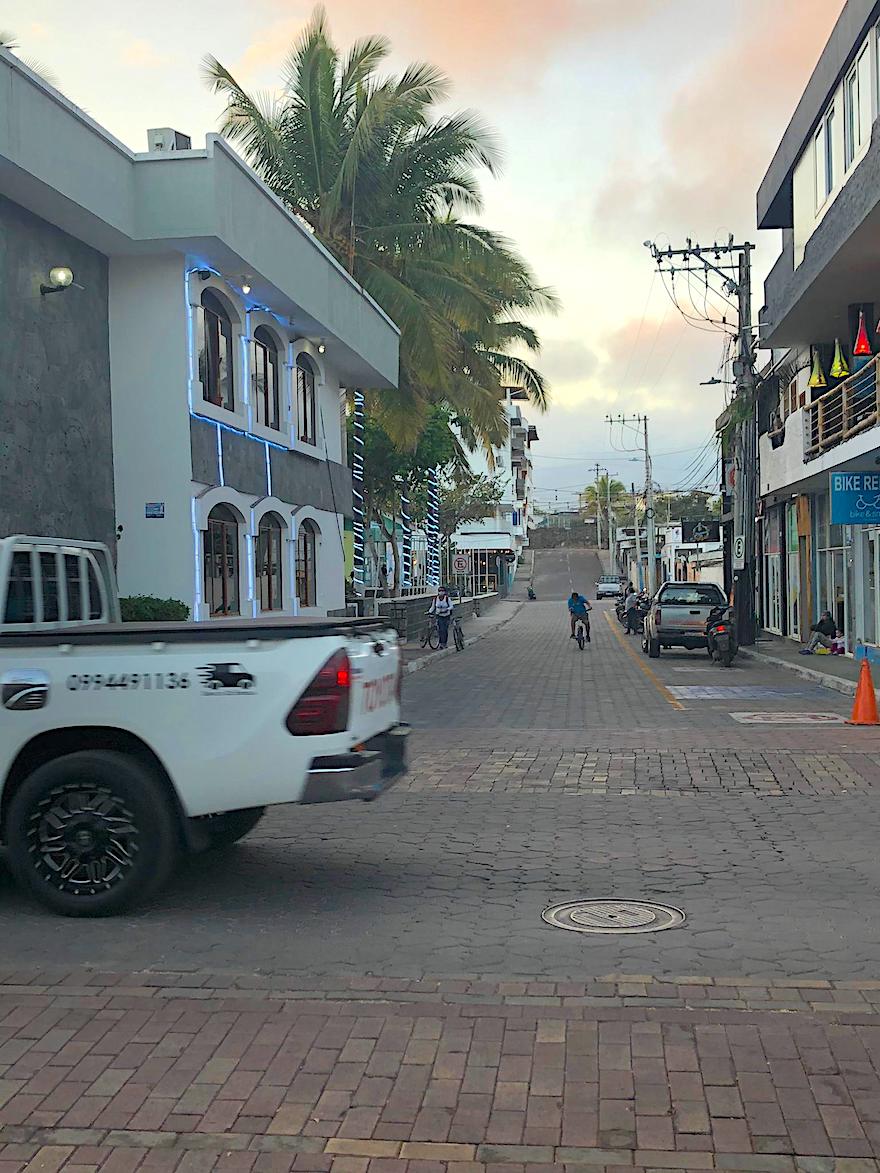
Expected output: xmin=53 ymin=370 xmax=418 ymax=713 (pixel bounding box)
xmin=645 ymin=236 xmax=758 ymax=644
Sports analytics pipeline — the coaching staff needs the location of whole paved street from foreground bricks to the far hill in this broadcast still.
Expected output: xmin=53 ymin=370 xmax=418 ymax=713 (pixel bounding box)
xmin=0 ymin=550 xmax=880 ymax=1173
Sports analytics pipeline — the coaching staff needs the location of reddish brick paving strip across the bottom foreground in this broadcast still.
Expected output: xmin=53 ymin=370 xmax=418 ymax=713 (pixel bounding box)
xmin=0 ymin=971 xmax=880 ymax=1173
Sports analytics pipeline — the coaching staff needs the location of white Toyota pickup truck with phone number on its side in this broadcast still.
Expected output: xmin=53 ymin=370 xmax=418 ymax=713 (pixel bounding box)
xmin=0 ymin=537 xmax=408 ymax=916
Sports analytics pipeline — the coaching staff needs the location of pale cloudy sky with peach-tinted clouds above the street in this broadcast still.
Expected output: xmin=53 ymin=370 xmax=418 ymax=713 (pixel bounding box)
xmin=10 ymin=0 xmax=842 ymax=506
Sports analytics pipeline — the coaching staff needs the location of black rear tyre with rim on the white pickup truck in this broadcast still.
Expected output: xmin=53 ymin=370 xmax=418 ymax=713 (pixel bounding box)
xmin=6 ymin=750 xmax=180 ymax=916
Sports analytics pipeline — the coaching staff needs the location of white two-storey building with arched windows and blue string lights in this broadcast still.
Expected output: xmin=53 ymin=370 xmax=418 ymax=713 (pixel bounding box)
xmin=0 ymin=52 xmax=399 ymax=621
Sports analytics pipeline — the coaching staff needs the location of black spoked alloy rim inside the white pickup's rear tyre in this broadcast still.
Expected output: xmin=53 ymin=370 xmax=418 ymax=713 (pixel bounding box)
xmin=27 ymin=782 xmax=141 ymax=896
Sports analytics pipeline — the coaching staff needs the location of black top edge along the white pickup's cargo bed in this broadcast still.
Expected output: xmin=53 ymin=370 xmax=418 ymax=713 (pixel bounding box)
xmin=0 ymin=617 xmax=392 ymax=651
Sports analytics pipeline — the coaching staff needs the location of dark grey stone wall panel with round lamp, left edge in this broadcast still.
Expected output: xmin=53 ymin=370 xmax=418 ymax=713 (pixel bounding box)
xmin=0 ymin=197 xmax=116 ymax=547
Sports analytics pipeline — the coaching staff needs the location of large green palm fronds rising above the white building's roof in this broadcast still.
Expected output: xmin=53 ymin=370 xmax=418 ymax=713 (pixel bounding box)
xmin=205 ymin=7 xmax=554 ymax=446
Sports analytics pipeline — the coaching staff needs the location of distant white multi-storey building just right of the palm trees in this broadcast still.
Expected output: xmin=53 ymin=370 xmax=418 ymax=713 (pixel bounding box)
xmin=453 ymin=387 xmax=539 ymax=592
